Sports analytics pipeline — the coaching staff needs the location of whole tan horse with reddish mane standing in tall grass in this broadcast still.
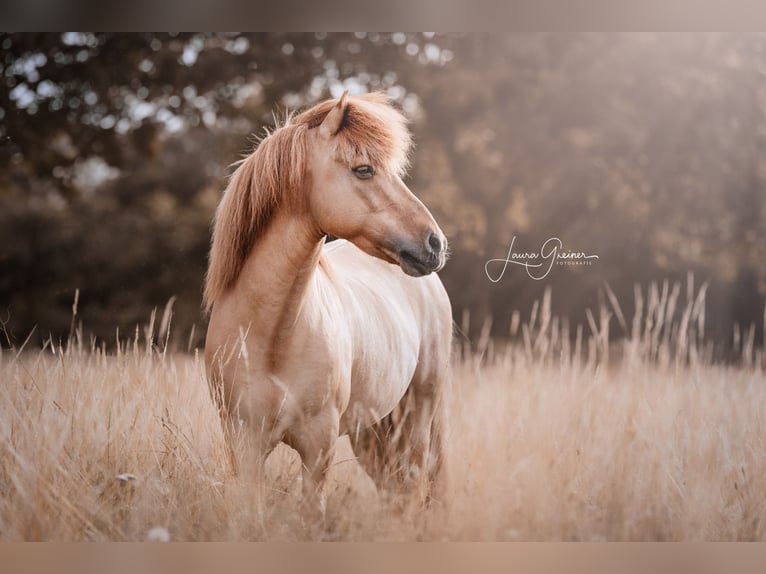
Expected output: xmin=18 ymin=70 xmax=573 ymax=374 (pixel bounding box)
xmin=205 ymin=93 xmax=452 ymax=508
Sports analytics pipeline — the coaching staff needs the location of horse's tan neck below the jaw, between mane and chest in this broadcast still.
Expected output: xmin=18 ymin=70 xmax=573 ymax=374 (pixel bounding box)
xmin=237 ymin=211 xmax=324 ymax=365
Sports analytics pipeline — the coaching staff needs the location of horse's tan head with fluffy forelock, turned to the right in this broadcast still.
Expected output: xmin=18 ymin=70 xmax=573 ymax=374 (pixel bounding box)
xmin=306 ymin=93 xmax=447 ymax=277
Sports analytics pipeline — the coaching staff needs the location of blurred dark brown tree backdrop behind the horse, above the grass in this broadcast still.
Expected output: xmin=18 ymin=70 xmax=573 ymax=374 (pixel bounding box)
xmin=0 ymin=33 xmax=766 ymax=354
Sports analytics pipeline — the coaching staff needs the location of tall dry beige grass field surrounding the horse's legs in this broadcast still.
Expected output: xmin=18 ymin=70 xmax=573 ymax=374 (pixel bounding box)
xmin=0 ymin=286 xmax=766 ymax=541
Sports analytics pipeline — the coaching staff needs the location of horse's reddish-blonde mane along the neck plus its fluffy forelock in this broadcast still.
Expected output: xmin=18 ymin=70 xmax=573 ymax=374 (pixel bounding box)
xmin=204 ymin=93 xmax=411 ymax=311
